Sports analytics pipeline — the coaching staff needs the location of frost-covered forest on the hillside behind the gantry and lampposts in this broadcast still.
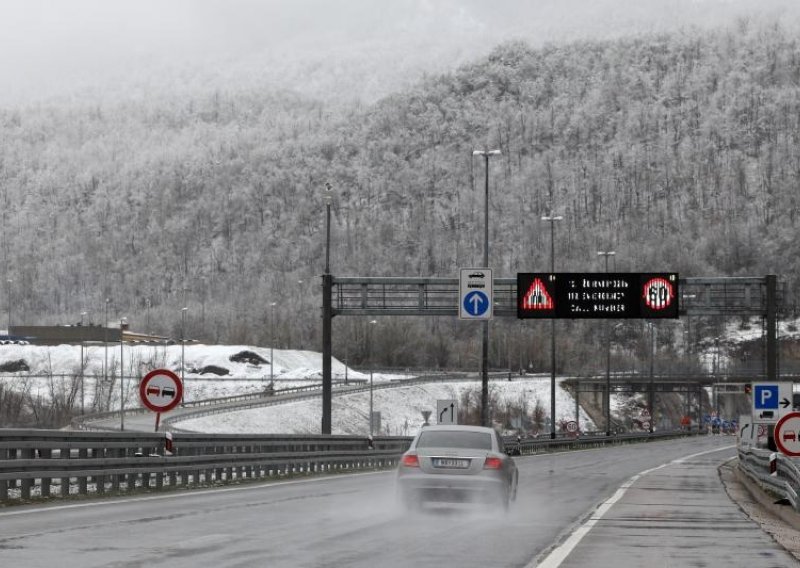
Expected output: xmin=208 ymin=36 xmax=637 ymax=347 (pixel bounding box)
xmin=0 ymin=15 xmax=800 ymax=370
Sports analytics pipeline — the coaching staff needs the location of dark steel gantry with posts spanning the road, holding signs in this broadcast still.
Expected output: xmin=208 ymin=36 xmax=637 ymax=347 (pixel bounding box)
xmin=322 ymin=274 xmax=779 ymax=434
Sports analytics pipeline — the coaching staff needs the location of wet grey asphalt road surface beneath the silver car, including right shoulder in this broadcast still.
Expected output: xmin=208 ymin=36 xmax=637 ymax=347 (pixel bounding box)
xmin=0 ymin=436 xmax=797 ymax=568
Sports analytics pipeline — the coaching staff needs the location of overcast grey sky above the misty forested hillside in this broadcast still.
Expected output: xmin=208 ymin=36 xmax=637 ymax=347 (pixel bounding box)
xmin=0 ymin=0 xmax=800 ymax=104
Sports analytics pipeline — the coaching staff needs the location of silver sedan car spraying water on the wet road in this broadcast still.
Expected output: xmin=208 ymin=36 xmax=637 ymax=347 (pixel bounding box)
xmin=397 ymin=425 xmax=518 ymax=510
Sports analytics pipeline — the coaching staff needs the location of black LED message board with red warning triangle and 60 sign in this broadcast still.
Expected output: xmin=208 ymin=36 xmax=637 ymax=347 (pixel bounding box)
xmin=517 ymin=272 xmax=678 ymax=319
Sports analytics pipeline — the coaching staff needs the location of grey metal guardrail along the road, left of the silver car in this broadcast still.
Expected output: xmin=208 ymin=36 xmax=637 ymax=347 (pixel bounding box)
xmin=0 ymin=430 xmax=411 ymax=502
